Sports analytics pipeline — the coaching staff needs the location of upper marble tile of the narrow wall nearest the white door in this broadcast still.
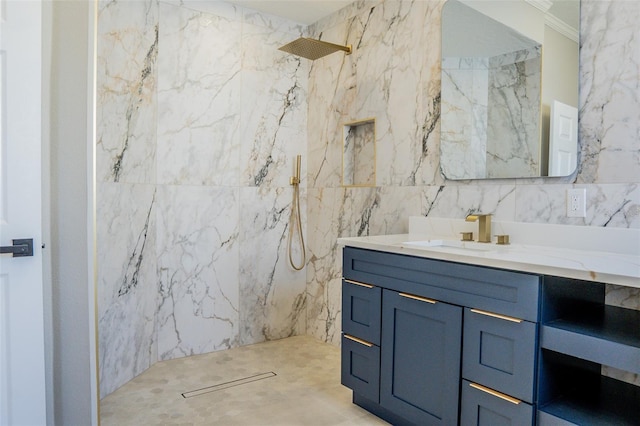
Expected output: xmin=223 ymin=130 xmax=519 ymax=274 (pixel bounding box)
xmin=96 ymin=0 xmax=158 ymax=183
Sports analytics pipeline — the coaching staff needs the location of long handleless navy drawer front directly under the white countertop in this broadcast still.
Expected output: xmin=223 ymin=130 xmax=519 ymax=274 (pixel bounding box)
xmin=342 ymin=247 xmax=541 ymax=322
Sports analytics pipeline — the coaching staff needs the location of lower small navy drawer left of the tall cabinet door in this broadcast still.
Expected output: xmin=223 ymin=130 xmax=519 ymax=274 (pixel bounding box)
xmin=340 ymin=334 xmax=380 ymax=403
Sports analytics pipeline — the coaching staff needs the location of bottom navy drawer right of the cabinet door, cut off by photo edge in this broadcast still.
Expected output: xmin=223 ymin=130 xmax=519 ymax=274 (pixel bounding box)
xmin=460 ymin=380 xmax=534 ymax=426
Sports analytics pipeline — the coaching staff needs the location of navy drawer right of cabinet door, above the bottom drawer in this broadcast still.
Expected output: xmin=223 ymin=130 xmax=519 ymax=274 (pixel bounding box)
xmin=462 ymin=308 xmax=537 ymax=402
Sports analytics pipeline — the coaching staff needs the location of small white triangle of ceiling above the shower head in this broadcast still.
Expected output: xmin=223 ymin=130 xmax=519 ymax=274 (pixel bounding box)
xmin=225 ymin=0 xmax=354 ymax=25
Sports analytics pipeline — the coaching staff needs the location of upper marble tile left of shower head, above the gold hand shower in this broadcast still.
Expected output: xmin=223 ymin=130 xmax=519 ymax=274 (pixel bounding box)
xmin=240 ymin=24 xmax=309 ymax=188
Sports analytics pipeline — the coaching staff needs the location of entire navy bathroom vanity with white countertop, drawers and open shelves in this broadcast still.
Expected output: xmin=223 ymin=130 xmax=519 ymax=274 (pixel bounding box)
xmin=339 ymin=218 xmax=640 ymax=426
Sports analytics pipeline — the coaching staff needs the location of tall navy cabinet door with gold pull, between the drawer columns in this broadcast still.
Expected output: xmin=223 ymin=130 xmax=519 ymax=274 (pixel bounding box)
xmin=380 ymin=290 xmax=462 ymax=425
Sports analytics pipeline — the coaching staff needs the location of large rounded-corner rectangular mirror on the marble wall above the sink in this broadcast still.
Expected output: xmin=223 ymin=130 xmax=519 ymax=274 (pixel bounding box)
xmin=440 ymin=0 xmax=580 ymax=180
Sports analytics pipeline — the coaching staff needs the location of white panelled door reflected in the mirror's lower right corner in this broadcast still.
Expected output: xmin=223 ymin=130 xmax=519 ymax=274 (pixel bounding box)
xmin=549 ymin=101 xmax=578 ymax=176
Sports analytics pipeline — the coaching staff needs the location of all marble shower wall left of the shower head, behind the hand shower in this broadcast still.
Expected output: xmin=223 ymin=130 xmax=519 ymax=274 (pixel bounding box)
xmin=97 ymin=0 xmax=309 ymax=397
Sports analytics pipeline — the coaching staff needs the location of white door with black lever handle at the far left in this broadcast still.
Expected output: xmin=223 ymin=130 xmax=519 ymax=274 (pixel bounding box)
xmin=0 ymin=0 xmax=46 ymax=426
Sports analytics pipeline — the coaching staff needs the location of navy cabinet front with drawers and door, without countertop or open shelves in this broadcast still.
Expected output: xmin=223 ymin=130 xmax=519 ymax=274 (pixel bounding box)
xmin=342 ymin=247 xmax=541 ymax=426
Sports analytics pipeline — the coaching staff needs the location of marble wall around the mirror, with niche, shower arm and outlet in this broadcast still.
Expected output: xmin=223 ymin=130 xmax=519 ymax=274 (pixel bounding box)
xmin=307 ymin=0 xmax=640 ymax=362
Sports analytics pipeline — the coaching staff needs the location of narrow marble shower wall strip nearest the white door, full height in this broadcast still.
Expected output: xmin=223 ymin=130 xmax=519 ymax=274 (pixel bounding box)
xmin=96 ymin=1 xmax=159 ymax=396
